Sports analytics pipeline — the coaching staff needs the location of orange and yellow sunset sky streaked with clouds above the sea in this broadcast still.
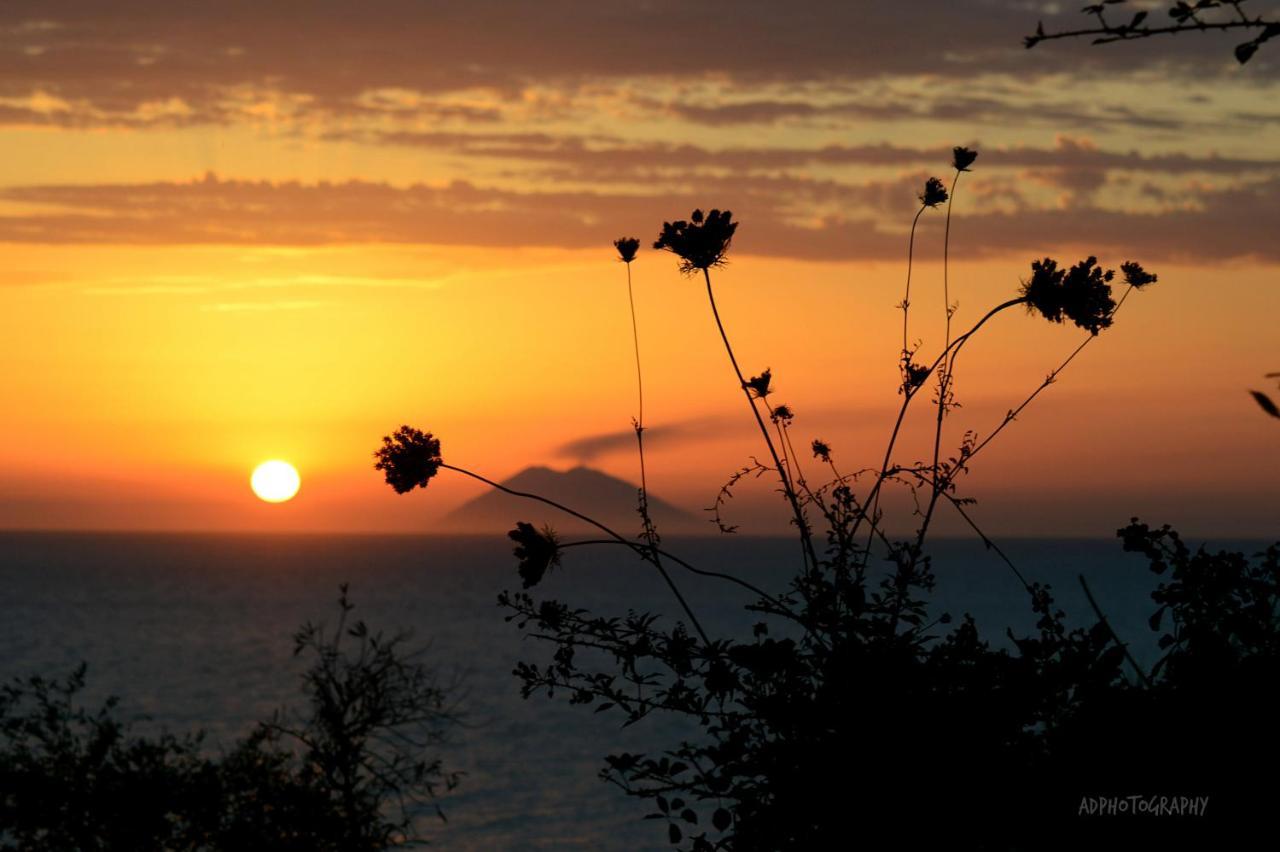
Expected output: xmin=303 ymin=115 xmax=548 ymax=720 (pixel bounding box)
xmin=0 ymin=0 xmax=1280 ymax=536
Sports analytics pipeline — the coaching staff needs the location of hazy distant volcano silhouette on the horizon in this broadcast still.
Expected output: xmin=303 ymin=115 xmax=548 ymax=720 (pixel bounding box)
xmin=444 ymin=466 xmax=705 ymax=536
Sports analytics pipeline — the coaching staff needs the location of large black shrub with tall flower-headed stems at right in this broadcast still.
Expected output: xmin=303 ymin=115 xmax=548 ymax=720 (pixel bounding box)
xmin=379 ymin=148 xmax=1280 ymax=852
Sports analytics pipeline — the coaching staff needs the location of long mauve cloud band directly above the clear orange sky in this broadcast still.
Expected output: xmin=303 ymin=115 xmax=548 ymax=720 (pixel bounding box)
xmin=0 ymin=165 xmax=1280 ymax=262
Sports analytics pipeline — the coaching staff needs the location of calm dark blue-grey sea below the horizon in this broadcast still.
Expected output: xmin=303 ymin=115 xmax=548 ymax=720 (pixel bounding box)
xmin=0 ymin=533 xmax=1256 ymax=851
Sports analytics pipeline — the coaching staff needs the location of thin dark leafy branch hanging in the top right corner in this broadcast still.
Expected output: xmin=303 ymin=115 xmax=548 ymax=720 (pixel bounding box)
xmin=1023 ymin=0 xmax=1280 ymax=65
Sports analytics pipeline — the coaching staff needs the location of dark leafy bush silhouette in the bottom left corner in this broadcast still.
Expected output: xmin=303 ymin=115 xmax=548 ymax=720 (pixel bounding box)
xmin=0 ymin=586 xmax=458 ymax=852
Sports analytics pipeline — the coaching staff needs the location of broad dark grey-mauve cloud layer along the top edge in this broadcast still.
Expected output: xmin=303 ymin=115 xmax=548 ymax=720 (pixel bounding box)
xmin=0 ymin=0 xmax=1249 ymax=122
